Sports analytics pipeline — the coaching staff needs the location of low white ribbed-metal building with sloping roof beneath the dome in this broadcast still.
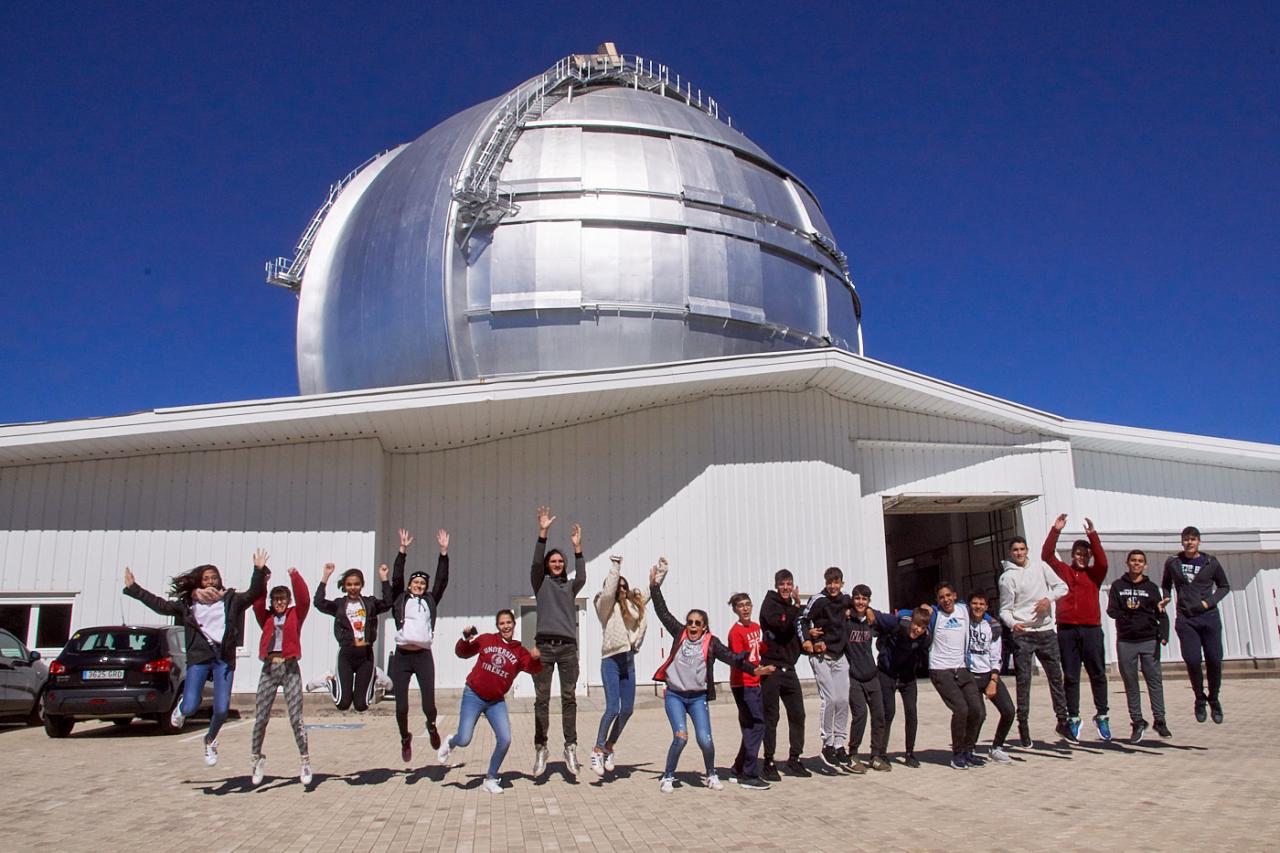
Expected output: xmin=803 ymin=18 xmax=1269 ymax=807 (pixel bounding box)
xmin=0 ymin=350 xmax=1280 ymax=693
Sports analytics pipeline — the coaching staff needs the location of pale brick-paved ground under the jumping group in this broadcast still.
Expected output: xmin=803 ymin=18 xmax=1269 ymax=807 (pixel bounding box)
xmin=0 ymin=680 xmax=1280 ymax=853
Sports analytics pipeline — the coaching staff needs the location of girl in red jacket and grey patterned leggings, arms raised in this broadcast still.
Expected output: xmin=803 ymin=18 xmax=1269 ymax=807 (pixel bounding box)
xmin=250 ymin=567 xmax=311 ymax=785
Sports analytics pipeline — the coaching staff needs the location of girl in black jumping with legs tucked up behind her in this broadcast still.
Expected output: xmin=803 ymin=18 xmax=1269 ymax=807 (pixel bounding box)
xmin=315 ymin=562 xmax=392 ymax=711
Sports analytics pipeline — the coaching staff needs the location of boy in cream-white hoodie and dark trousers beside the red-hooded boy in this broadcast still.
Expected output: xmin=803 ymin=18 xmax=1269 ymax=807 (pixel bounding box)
xmin=1000 ymin=537 xmax=1079 ymax=749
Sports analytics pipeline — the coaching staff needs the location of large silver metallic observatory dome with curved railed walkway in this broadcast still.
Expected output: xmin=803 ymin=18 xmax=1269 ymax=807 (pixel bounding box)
xmin=268 ymin=45 xmax=861 ymax=393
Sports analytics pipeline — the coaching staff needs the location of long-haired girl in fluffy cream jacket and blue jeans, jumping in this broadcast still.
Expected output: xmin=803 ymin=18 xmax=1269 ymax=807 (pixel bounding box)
xmin=591 ymin=556 xmax=649 ymax=776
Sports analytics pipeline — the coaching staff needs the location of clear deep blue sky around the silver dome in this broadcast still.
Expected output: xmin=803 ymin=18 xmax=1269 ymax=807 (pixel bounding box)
xmin=0 ymin=6 xmax=1280 ymax=443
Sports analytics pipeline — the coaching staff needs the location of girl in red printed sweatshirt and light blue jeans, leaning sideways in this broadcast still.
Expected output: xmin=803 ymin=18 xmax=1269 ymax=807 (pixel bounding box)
xmin=436 ymin=610 xmax=543 ymax=794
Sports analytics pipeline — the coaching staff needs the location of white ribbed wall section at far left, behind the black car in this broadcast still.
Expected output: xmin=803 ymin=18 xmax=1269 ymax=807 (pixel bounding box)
xmin=0 ymin=439 xmax=384 ymax=692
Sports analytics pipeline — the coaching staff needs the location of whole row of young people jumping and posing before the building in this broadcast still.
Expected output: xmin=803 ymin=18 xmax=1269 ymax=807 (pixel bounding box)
xmin=124 ymin=506 xmax=1230 ymax=794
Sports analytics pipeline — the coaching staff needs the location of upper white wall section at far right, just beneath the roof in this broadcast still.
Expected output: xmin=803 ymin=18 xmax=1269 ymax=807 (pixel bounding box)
xmin=1074 ymin=451 xmax=1280 ymax=530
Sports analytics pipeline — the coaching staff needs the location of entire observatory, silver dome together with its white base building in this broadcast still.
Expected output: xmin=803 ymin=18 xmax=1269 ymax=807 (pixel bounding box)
xmin=0 ymin=46 xmax=1280 ymax=692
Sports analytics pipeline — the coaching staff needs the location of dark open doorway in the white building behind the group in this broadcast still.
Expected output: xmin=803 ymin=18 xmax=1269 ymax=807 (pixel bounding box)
xmin=884 ymin=494 xmax=1034 ymax=608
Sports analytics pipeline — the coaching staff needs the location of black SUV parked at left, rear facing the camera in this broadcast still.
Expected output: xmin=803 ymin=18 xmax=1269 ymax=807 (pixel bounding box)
xmin=45 ymin=625 xmax=211 ymax=738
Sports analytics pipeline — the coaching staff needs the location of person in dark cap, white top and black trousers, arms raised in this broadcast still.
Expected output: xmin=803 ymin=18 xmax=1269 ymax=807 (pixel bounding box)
xmin=387 ymin=528 xmax=449 ymax=762
